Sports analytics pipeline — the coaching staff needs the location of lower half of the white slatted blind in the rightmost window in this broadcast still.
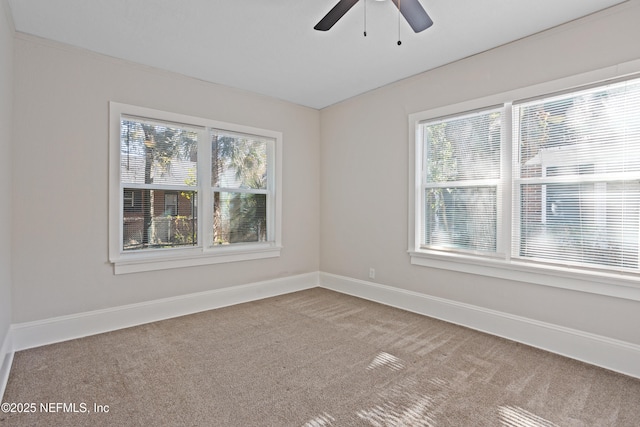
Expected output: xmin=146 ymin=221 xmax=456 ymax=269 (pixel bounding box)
xmin=517 ymin=181 xmax=640 ymax=269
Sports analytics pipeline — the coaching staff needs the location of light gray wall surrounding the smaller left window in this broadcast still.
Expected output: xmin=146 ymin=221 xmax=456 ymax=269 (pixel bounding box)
xmin=11 ymin=33 xmax=320 ymax=323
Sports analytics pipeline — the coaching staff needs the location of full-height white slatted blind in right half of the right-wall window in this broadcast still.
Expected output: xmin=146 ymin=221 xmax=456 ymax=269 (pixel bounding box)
xmin=512 ymin=80 xmax=640 ymax=270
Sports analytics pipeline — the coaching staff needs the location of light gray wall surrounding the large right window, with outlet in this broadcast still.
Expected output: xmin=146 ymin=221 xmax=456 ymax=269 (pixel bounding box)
xmin=320 ymin=0 xmax=640 ymax=344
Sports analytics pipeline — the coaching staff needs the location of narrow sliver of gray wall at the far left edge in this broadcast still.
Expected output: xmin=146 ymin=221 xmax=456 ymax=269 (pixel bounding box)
xmin=0 ymin=0 xmax=13 ymax=352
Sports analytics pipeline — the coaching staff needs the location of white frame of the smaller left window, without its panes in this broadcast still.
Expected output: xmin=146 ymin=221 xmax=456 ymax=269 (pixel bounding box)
xmin=108 ymin=101 xmax=282 ymax=274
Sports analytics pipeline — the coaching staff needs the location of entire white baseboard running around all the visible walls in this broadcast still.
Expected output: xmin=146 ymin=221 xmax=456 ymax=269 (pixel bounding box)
xmin=6 ymin=272 xmax=640 ymax=398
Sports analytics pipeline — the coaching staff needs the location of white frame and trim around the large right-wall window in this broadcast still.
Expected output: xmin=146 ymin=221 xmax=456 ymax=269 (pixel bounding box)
xmin=407 ymin=60 xmax=640 ymax=301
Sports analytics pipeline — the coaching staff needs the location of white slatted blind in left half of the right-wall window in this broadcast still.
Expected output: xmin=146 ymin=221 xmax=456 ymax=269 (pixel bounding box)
xmin=422 ymin=109 xmax=503 ymax=253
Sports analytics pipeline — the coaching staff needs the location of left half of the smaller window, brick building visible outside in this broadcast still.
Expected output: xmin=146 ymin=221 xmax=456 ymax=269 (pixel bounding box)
xmin=120 ymin=116 xmax=198 ymax=251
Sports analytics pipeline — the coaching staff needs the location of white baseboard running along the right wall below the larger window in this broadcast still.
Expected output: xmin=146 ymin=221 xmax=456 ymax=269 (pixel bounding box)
xmin=320 ymin=273 xmax=640 ymax=378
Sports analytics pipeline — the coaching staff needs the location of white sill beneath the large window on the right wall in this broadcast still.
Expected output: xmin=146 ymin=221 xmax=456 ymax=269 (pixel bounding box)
xmin=409 ymin=251 xmax=640 ymax=301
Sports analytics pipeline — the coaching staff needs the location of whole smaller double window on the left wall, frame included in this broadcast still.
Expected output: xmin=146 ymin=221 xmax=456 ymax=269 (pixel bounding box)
xmin=109 ymin=103 xmax=282 ymax=273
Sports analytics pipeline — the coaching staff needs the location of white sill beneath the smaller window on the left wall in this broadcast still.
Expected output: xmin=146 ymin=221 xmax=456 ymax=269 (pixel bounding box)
xmin=111 ymin=243 xmax=282 ymax=274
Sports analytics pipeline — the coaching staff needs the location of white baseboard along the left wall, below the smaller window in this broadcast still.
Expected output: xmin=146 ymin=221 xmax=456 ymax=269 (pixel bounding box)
xmin=10 ymin=272 xmax=318 ymax=351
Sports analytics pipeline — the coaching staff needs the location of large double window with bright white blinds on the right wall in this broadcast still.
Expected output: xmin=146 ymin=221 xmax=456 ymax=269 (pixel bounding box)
xmin=409 ymin=74 xmax=640 ymax=294
